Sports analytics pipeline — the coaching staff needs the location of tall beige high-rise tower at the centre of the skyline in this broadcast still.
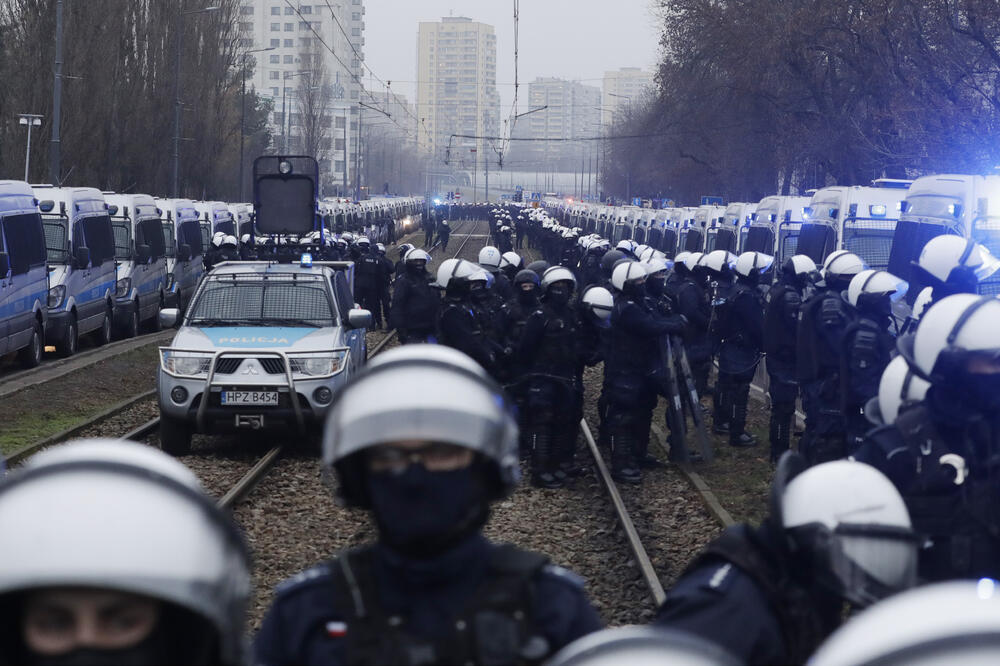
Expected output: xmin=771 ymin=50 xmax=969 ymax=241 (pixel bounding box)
xmin=417 ymin=16 xmax=500 ymax=166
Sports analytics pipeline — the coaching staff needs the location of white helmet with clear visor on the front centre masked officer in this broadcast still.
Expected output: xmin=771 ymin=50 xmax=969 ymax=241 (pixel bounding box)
xmin=323 ymin=344 xmax=520 ymax=507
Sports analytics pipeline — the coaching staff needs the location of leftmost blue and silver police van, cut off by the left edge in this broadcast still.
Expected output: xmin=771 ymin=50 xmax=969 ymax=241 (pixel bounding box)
xmin=0 ymin=180 xmax=48 ymax=368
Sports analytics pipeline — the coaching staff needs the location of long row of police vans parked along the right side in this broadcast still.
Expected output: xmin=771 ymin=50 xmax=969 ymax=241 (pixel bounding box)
xmin=544 ymin=174 xmax=1000 ymax=294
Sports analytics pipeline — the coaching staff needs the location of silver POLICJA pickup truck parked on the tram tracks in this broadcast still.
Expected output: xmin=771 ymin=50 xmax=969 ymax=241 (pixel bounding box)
xmin=157 ymin=254 xmax=372 ymax=455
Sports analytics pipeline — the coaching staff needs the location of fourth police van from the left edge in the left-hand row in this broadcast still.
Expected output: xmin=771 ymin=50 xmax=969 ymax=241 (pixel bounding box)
xmin=156 ymin=199 xmax=203 ymax=310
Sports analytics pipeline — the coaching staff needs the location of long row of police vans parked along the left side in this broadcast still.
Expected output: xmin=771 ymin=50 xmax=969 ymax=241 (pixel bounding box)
xmin=0 ymin=180 xmax=422 ymax=367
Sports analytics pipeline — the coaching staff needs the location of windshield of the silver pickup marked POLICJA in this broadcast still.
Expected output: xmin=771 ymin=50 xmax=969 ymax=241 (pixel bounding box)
xmin=189 ymin=274 xmax=336 ymax=328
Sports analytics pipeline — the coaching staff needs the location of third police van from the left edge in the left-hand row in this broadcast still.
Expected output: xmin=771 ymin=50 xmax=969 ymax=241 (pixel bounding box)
xmin=104 ymin=193 xmax=167 ymax=338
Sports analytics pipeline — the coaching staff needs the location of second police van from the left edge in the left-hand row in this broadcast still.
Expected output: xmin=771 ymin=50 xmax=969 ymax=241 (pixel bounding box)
xmin=32 ymin=185 xmax=116 ymax=356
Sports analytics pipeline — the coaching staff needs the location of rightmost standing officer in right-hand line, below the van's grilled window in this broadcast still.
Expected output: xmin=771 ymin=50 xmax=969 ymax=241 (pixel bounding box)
xmin=840 ymin=269 xmax=908 ymax=453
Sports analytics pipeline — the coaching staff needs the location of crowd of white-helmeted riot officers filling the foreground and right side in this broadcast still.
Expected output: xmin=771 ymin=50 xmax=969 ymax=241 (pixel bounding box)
xmin=0 ymin=208 xmax=1000 ymax=666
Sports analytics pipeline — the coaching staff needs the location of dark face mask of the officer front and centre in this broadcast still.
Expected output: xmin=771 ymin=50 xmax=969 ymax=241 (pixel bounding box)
xmin=368 ymin=464 xmax=489 ymax=558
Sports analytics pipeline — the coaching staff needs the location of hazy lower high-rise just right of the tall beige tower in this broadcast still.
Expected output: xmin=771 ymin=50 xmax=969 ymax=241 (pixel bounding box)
xmin=510 ymin=78 xmax=601 ymax=171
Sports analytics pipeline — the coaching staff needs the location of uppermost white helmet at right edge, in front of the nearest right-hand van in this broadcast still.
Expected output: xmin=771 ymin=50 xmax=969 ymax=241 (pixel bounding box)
xmin=914 ymin=235 xmax=1000 ymax=293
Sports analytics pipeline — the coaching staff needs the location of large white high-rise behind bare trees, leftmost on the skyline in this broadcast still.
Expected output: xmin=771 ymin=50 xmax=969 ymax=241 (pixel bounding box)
xmin=240 ymin=0 xmax=365 ymax=194
